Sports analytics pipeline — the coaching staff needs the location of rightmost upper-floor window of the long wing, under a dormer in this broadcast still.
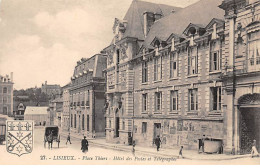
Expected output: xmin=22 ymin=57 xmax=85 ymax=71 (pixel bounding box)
xmin=210 ymin=41 xmax=221 ymax=72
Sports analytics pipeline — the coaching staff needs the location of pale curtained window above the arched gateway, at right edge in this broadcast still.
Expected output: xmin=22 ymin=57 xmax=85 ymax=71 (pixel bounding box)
xmin=248 ymin=31 xmax=260 ymax=70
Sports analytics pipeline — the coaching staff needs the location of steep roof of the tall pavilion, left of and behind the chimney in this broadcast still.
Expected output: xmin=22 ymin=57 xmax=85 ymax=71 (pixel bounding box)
xmin=122 ymin=0 xmax=181 ymax=40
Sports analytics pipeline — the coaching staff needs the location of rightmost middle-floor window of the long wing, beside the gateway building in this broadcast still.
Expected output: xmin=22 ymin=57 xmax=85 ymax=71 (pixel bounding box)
xmin=210 ymin=87 xmax=221 ymax=111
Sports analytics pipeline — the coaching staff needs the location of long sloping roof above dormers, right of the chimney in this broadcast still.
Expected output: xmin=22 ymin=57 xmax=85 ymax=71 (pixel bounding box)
xmin=144 ymin=0 xmax=225 ymax=48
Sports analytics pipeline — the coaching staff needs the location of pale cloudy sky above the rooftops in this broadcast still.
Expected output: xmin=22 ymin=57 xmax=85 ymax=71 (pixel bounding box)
xmin=0 ymin=0 xmax=198 ymax=89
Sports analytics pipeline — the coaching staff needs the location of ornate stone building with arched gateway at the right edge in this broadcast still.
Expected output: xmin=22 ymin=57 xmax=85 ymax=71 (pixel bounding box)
xmin=220 ymin=0 xmax=260 ymax=154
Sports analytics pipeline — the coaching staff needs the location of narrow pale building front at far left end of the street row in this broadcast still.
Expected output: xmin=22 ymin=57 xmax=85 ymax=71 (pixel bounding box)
xmin=61 ymin=83 xmax=70 ymax=131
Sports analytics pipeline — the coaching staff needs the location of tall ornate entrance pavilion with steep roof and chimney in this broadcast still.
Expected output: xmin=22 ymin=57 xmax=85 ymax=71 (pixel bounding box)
xmin=104 ymin=0 xmax=179 ymax=144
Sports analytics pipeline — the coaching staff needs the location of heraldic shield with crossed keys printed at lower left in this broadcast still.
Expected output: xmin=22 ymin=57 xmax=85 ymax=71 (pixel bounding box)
xmin=6 ymin=121 xmax=33 ymax=157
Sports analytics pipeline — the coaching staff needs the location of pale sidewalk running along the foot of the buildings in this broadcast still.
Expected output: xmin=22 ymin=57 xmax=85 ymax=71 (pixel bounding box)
xmin=61 ymin=133 xmax=251 ymax=161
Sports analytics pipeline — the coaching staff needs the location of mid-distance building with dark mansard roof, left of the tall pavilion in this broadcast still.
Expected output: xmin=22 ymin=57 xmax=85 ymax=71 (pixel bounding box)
xmin=69 ymin=54 xmax=106 ymax=137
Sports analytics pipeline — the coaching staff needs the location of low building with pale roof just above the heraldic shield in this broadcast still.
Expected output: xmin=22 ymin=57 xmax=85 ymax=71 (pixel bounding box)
xmin=24 ymin=106 xmax=49 ymax=126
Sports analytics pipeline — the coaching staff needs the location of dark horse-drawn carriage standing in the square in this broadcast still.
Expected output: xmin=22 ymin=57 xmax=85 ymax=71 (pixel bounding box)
xmin=44 ymin=126 xmax=60 ymax=148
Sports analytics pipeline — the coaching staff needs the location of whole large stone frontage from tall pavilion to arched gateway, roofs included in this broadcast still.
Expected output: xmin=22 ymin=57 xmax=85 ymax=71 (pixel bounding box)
xmin=104 ymin=0 xmax=260 ymax=153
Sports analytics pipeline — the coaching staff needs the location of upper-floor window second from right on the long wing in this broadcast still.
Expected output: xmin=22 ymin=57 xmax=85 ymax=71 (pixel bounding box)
xmin=188 ymin=47 xmax=198 ymax=75
